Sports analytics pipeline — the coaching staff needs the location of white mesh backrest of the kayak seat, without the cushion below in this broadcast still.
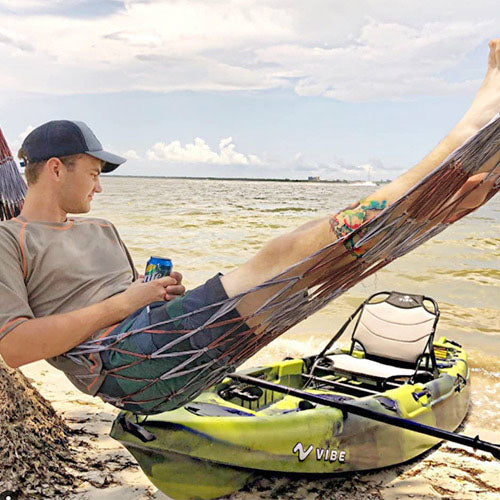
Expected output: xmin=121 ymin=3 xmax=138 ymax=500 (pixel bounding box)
xmin=352 ymin=302 xmax=436 ymax=363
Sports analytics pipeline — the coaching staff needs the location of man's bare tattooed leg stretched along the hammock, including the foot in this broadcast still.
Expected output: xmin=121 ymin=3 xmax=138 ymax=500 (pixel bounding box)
xmin=222 ymin=39 xmax=500 ymax=316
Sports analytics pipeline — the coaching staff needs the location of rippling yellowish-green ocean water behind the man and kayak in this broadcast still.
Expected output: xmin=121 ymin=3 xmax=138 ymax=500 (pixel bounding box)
xmin=89 ymin=176 xmax=500 ymax=429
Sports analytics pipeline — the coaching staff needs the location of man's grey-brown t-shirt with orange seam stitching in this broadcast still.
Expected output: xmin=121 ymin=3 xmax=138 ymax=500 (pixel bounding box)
xmin=0 ymin=216 xmax=137 ymax=395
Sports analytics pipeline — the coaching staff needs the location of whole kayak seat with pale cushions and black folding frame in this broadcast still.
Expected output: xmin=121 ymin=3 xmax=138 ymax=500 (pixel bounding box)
xmin=318 ymin=291 xmax=439 ymax=381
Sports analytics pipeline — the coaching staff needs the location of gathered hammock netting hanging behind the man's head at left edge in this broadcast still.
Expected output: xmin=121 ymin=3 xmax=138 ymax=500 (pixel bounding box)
xmin=0 ymin=129 xmax=26 ymax=220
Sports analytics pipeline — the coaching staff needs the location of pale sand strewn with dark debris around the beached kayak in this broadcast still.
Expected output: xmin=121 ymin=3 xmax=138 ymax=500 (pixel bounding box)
xmin=21 ymin=361 xmax=500 ymax=500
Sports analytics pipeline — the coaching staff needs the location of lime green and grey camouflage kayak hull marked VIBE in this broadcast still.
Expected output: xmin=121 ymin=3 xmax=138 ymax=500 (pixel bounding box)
xmin=111 ymin=338 xmax=470 ymax=499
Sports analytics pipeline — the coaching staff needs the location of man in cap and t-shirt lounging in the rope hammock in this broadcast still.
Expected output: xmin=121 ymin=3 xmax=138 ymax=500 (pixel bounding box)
xmin=0 ymin=39 xmax=500 ymax=413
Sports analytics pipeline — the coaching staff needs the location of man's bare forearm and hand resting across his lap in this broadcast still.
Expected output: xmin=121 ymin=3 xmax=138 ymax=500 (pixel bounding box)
xmin=0 ymin=272 xmax=184 ymax=368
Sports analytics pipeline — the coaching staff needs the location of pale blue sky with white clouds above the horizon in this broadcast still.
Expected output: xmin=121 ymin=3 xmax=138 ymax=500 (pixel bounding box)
xmin=0 ymin=0 xmax=500 ymax=180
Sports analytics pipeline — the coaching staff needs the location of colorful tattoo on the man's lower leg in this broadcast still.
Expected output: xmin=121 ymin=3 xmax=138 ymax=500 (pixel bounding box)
xmin=330 ymin=199 xmax=387 ymax=257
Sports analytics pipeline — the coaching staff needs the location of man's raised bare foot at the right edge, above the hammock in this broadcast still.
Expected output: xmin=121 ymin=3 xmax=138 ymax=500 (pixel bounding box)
xmin=461 ymin=38 xmax=500 ymax=134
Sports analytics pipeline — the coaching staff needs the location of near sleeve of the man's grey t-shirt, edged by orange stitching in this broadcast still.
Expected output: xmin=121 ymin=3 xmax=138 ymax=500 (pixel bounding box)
xmin=0 ymin=231 xmax=35 ymax=340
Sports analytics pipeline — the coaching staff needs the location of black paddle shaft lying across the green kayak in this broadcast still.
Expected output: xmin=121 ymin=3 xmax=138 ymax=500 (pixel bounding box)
xmin=228 ymin=374 xmax=500 ymax=459
